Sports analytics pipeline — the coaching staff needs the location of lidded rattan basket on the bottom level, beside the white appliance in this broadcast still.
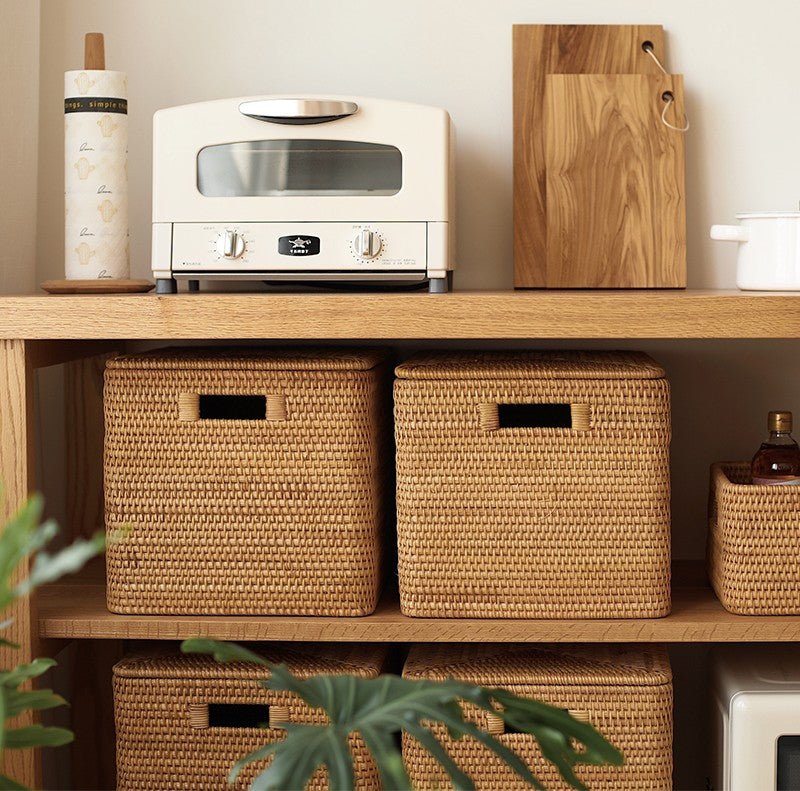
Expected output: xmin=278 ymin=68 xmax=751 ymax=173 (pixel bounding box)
xmin=403 ymin=644 xmax=672 ymax=791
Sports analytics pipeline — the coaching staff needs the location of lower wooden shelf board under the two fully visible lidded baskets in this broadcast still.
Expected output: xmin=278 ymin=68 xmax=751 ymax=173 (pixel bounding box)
xmin=38 ymin=562 xmax=800 ymax=643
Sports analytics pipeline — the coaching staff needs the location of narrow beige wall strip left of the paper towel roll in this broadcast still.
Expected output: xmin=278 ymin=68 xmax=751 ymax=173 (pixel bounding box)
xmin=0 ymin=0 xmax=39 ymax=294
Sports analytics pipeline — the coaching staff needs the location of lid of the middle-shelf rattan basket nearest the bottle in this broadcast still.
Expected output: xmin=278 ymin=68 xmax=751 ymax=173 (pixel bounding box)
xmin=395 ymin=351 xmax=666 ymax=379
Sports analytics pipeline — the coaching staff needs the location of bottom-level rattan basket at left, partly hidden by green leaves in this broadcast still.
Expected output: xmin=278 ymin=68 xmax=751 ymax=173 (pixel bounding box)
xmin=114 ymin=643 xmax=386 ymax=791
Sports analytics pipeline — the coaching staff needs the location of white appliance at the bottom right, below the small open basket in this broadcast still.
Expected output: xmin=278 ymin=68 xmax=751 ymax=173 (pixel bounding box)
xmin=710 ymin=644 xmax=800 ymax=791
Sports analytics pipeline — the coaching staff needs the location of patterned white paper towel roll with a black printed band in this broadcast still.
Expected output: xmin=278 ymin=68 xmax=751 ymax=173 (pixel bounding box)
xmin=64 ymin=69 xmax=130 ymax=280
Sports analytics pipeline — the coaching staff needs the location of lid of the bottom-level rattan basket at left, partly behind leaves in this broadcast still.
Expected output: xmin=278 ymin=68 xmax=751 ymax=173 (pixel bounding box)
xmin=114 ymin=643 xmax=388 ymax=679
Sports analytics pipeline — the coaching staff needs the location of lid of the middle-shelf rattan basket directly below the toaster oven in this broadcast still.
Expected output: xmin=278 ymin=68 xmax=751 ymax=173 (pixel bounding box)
xmin=106 ymin=347 xmax=387 ymax=371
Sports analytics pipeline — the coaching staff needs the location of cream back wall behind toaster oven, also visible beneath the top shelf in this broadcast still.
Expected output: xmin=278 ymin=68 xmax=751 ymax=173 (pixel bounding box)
xmin=39 ymin=0 xmax=800 ymax=557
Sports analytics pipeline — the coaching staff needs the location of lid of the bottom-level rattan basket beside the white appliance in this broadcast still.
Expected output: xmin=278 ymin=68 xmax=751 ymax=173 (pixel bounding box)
xmin=403 ymin=643 xmax=672 ymax=687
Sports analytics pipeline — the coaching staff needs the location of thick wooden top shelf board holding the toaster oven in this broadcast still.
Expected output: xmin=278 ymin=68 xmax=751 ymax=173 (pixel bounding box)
xmin=0 ymin=290 xmax=800 ymax=340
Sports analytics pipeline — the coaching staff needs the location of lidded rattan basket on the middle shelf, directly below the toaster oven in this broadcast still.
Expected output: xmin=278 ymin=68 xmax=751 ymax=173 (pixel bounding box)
xmin=105 ymin=349 xmax=391 ymax=616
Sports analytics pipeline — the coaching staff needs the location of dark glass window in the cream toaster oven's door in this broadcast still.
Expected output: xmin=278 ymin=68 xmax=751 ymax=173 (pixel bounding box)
xmin=197 ymin=140 xmax=403 ymax=198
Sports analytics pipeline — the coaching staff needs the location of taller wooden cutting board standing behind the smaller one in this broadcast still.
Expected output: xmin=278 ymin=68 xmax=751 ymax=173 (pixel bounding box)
xmin=513 ymin=25 xmax=676 ymax=288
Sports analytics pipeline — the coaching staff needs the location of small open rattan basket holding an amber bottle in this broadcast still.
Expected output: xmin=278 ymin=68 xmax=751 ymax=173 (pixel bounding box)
xmin=707 ymin=462 xmax=800 ymax=615
